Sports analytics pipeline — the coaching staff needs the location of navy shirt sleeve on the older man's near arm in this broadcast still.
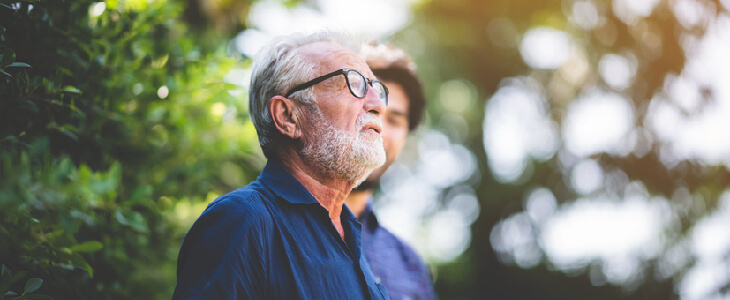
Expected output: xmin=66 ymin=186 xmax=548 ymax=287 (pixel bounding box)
xmin=173 ymin=194 xmax=273 ymax=299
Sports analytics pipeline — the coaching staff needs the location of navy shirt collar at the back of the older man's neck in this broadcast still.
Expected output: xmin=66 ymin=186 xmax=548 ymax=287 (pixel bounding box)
xmin=258 ymin=160 xmax=319 ymax=204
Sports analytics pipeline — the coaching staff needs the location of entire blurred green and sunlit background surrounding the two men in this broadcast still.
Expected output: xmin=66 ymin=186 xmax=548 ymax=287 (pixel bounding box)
xmin=0 ymin=0 xmax=730 ymax=299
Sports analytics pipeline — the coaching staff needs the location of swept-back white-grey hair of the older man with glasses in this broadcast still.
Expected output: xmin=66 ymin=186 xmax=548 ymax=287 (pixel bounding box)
xmin=249 ymin=31 xmax=360 ymax=158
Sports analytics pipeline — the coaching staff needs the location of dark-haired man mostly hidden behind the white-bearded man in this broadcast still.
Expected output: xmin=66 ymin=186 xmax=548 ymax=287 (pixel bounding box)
xmin=345 ymin=44 xmax=436 ymax=300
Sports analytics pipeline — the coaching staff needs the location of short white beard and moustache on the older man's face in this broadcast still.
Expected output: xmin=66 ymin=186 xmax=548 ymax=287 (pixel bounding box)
xmin=300 ymin=106 xmax=386 ymax=186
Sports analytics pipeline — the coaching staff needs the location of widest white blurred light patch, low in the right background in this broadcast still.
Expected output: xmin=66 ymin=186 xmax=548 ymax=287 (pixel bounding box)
xmin=542 ymin=198 xmax=666 ymax=267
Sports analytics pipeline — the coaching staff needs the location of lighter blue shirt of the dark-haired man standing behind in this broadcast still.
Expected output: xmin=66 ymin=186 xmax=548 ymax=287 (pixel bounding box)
xmin=360 ymin=203 xmax=436 ymax=300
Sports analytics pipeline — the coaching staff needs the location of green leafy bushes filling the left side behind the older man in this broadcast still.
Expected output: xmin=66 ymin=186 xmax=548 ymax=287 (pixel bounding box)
xmin=0 ymin=0 xmax=263 ymax=299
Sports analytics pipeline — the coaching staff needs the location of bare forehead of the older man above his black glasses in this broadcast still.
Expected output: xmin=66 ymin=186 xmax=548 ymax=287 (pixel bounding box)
xmin=302 ymin=41 xmax=374 ymax=77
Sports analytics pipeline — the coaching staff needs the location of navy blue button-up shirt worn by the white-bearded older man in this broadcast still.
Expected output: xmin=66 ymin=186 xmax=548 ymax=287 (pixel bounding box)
xmin=173 ymin=161 xmax=388 ymax=299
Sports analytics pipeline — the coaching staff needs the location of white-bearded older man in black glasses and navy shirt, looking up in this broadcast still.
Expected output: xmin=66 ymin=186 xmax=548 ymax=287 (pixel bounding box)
xmin=173 ymin=32 xmax=388 ymax=299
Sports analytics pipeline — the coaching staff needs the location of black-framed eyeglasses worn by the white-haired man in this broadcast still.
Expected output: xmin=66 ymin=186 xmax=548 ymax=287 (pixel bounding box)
xmin=284 ymin=69 xmax=388 ymax=105
